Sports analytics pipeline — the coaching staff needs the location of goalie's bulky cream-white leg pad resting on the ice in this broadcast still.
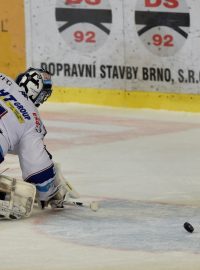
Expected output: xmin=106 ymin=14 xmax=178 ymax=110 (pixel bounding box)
xmin=0 ymin=175 xmax=36 ymax=219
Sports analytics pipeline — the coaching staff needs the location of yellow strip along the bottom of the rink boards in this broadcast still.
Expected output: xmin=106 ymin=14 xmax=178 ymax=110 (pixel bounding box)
xmin=50 ymin=87 xmax=200 ymax=112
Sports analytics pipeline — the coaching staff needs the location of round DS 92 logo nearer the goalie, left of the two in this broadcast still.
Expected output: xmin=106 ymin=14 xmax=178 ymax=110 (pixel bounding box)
xmin=56 ymin=0 xmax=112 ymax=53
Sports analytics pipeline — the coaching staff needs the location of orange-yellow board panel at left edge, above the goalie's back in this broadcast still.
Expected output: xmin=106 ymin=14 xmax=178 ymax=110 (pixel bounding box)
xmin=0 ymin=0 xmax=26 ymax=78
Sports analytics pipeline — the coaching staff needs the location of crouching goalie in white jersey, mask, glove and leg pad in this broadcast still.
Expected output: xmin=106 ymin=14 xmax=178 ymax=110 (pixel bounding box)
xmin=0 ymin=68 xmax=84 ymax=219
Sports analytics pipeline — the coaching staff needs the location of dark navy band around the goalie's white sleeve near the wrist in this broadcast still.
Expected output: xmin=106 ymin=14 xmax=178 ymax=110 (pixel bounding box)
xmin=25 ymin=165 xmax=55 ymax=184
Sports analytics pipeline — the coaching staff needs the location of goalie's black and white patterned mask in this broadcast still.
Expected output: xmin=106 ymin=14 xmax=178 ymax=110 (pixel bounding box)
xmin=16 ymin=68 xmax=52 ymax=107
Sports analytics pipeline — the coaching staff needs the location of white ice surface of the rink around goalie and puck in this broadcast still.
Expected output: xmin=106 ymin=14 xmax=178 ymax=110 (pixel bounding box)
xmin=0 ymin=104 xmax=200 ymax=270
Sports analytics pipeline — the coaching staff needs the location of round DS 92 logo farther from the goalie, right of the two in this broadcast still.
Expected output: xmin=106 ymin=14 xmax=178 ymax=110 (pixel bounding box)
xmin=135 ymin=0 xmax=190 ymax=56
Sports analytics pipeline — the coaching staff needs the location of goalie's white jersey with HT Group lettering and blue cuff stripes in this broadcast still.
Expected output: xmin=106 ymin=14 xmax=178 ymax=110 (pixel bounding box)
xmin=0 ymin=73 xmax=56 ymax=201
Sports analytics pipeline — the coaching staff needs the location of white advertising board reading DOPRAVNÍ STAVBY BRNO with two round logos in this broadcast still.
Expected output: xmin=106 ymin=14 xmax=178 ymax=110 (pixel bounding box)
xmin=25 ymin=0 xmax=200 ymax=94
